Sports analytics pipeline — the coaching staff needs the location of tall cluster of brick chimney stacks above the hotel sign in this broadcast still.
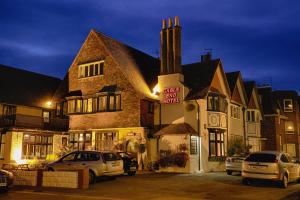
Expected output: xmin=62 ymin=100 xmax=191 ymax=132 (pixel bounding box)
xmin=160 ymin=16 xmax=181 ymax=75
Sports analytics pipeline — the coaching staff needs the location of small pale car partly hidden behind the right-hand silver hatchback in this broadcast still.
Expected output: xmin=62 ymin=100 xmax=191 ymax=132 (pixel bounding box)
xmin=225 ymin=154 xmax=245 ymax=175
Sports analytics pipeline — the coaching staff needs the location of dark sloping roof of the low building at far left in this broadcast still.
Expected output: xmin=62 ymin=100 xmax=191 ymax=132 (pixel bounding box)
xmin=0 ymin=64 xmax=61 ymax=107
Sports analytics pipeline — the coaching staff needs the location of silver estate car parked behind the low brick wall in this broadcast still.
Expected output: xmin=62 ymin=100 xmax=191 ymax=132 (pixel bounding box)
xmin=47 ymin=151 xmax=124 ymax=183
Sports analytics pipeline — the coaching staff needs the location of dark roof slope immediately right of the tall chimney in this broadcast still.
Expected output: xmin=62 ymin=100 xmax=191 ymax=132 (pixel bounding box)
xmin=182 ymin=59 xmax=226 ymax=100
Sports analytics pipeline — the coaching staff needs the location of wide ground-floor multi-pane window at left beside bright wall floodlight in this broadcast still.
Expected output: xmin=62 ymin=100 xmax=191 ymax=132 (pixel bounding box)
xmin=22 ymin=133 xmax=53 ymax=159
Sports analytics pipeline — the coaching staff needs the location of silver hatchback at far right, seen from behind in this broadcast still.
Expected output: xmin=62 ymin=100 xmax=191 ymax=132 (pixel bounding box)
xmin=242 ymin=151 xmax=300 ymax=188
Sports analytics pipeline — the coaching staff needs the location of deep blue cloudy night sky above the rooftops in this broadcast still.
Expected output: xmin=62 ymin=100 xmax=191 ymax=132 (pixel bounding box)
xmin=0 ymin=0 xmax=300 ymax=92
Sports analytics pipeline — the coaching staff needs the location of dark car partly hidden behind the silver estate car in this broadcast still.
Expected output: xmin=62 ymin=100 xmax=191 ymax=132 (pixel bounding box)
xmin=117 ymin=152 xmax=138 ymax=176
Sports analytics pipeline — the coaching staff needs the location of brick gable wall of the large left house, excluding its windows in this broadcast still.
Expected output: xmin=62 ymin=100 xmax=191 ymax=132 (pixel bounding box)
xmin=69 ymin=32 xmax=141 ymax=130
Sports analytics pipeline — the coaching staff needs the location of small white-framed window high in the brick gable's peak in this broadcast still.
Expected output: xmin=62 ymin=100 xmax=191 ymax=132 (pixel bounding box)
xmin=78 ymin=60 xmax=104 ymax=78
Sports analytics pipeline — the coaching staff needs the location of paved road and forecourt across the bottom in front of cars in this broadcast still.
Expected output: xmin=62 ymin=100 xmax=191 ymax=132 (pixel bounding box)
xmin=0 ymin=173 xmax=300 ymax=200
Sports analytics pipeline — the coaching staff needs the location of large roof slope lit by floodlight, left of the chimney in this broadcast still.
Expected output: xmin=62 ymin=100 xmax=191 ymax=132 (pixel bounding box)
xmin=92 ymin=30 xmax=160 ymax=96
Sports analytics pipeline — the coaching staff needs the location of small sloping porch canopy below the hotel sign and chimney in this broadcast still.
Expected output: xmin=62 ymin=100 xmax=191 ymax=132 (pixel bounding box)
xmin=154 ymin=123 xmax=198 ymax=137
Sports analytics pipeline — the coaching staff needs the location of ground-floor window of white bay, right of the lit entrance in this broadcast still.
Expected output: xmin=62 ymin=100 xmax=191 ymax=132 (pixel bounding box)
xmin=209 ymin=132 xmax=225 ymax=157
